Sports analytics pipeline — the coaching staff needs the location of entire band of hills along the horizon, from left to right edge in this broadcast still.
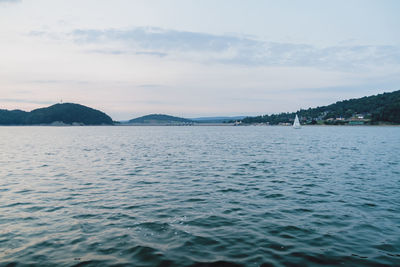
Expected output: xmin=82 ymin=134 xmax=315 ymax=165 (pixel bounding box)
xmin=0 ymin=90 xmax=400 ymax=125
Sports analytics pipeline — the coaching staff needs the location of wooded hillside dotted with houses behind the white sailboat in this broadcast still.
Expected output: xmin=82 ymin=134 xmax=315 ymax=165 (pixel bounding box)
xmin=242 ymin=90 xmax=400 ymax=125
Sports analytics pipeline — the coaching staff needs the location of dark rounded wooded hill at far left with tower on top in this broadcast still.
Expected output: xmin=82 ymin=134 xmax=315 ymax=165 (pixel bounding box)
xmin=0 ymin=103 xmax=113 ymax=125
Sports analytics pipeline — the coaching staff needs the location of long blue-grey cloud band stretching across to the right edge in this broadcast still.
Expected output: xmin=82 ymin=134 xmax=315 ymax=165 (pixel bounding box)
xmin=65 ymin=27 xmax=400 ymax=71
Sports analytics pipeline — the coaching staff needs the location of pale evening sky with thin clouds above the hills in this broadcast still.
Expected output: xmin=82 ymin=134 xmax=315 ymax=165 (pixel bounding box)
xmin=0 ymin=0 xmax=400 ymax=120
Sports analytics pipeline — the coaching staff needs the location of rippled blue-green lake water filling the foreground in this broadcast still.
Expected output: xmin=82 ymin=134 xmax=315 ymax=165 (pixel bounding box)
xmin=0 ymin=127 xmax=400 ymax=266
